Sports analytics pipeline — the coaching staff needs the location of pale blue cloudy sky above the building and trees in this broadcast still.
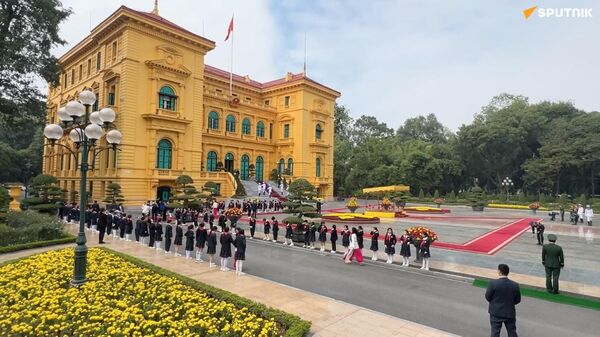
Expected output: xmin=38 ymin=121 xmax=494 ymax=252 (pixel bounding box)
xmin=53 ymin=0 xmax=600 ymax=131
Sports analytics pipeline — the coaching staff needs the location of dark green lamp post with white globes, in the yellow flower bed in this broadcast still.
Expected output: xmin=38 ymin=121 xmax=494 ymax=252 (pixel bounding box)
xmin=44 ymin=90 xmax=122 ymax=286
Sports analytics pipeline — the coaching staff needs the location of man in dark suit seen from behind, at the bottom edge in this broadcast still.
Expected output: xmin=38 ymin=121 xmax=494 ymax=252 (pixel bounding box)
xmin=485 ymin=264 xmax=521 ymax=337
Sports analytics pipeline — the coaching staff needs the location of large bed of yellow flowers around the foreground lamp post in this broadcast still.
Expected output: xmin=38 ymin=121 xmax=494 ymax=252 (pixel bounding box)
xmin=0 ymin=249 xmax=279 ymax=337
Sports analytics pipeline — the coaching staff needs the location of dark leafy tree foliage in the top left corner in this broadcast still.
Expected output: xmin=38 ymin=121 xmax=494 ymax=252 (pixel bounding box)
xmin=0 ymin=0 xmax=71 ymax=125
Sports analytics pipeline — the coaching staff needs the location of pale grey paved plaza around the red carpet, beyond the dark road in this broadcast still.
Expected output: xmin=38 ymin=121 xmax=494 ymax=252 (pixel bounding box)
xmin=127 ymin=200 xmax=600 ymax=297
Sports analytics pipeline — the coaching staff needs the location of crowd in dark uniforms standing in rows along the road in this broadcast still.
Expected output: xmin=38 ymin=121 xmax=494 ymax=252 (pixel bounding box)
xmin=59 ymin=200 xmax=432 ymax=274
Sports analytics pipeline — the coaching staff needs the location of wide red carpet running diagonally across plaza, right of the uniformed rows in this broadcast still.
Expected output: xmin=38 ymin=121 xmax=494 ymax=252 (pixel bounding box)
xmin=432 ymin=218 xmax=540 ymax=255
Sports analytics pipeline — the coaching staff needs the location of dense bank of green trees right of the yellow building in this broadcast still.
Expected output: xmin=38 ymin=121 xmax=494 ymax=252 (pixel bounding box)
xmin=334 ymin=94 xmax=600 ymax=196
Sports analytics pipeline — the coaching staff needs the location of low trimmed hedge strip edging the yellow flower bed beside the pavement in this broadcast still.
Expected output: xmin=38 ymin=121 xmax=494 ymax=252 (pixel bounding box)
xmin=100 ymin=247 xmax=311 ymax=337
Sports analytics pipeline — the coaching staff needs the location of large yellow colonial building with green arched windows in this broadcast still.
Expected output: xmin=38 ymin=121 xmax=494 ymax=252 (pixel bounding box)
xmin=43 ymin=6 xmax=340 ymax=205
